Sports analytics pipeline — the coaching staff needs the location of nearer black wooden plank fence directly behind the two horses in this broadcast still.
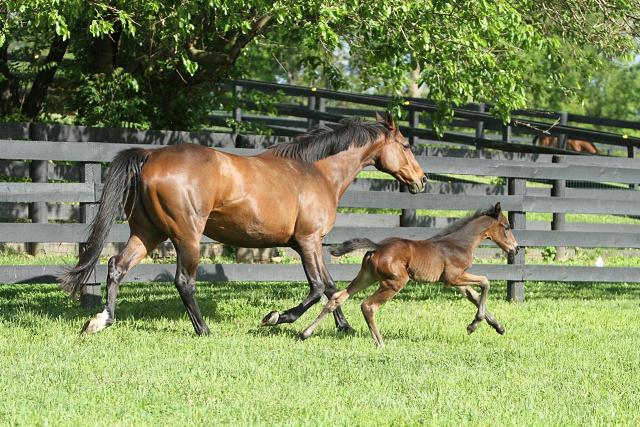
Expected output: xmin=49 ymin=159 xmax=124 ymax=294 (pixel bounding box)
xmin=0 ymin=122 xmax=640 ymax=306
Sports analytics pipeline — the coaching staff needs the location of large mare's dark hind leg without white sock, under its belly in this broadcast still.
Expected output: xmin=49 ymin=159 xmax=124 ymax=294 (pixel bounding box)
xmin=173 ymin=239 xmax=209 ymax=335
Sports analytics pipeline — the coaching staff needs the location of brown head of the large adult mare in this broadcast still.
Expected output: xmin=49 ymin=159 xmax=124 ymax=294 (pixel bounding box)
xmin=375 ymin=113 xmax=427 ymax=194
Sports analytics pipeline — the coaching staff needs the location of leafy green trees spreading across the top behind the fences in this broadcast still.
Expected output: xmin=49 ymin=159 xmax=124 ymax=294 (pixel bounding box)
xmin=0 ymin=0 xmax=640 ymax=129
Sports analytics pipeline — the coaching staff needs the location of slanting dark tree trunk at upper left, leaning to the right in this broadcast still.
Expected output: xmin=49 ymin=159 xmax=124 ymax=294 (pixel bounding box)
xmin=22 ymin=36 xmax=69 ymax=119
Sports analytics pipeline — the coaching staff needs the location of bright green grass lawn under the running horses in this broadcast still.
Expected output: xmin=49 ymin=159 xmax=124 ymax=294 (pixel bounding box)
xmin=0 ymin=283 xmax=640 ymax=425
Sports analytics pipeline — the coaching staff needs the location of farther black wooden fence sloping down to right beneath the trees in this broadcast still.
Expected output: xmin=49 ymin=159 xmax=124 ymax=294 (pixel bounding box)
xmin=215 ymin=80 xmax=640 ymax=158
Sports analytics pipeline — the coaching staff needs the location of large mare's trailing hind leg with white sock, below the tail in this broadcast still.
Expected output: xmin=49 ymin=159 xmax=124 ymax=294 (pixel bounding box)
xmin=80 ymin=233 xmax=165 ymax=334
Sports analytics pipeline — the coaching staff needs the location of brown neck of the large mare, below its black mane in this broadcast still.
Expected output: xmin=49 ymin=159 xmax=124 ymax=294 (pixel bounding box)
xmin=314 ymin=145 xmax=375 ymax=201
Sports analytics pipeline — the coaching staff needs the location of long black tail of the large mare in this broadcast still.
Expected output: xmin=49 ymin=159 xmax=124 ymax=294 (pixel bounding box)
xmin=58 ymin=148 xmax=149 ymax=299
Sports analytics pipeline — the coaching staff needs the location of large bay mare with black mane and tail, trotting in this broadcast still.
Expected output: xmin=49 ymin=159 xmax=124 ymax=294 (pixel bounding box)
xmin=60 ymin=114 xmax=426 ymax=335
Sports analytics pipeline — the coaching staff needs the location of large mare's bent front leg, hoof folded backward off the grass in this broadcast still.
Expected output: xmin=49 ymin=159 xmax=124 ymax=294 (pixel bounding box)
xmin=261 ymin=238 xmax=325 ymax=326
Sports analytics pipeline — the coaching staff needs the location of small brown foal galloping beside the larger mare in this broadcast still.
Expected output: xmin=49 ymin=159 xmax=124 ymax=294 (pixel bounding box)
xmin=300 ymin=203 xmax=519 ymax=346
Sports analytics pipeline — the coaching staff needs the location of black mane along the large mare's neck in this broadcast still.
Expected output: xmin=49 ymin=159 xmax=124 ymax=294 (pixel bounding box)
xmin=269 ymin=119 xmax=391 ymax=163
